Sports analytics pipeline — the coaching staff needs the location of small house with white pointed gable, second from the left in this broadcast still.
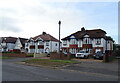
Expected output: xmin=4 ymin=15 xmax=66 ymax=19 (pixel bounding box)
xmin=14 ymin=37 xmax=28 ymax=52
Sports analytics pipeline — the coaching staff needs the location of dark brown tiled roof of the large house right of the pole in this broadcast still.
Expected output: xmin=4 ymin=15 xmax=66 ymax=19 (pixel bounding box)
xmin=62 ymin=29 xmax=106 ymax=40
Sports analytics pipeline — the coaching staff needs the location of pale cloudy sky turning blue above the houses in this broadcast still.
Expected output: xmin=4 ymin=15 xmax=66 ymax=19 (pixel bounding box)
xmin=0 ymin=0 xmax=118 ymax=42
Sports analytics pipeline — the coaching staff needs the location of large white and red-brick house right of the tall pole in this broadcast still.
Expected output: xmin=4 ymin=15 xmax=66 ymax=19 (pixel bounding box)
xmin=61 ymin=27 xmax=114 ymax=54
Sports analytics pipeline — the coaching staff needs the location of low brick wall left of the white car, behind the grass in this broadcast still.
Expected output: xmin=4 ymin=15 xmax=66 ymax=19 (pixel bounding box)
xmin=50 ymin=53 xmax=71 ymax=60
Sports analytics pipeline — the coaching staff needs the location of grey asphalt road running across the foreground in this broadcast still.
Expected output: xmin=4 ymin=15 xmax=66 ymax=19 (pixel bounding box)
xmin=2 ymin=58 xmax=118 ymax=81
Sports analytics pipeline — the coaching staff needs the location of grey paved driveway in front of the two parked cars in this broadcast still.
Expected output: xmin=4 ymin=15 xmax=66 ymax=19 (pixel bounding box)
xmin=61 ymin=59 xmax=118 ymax=77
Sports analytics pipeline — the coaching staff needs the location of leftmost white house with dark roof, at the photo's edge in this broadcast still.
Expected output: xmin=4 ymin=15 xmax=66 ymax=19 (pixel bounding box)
xmin=0 ymin=37 xmax=17 ymax=52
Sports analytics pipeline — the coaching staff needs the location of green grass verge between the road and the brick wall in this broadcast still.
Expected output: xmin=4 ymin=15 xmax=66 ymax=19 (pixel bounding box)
xmin=23 ymin=59 xmax=78 ymax=67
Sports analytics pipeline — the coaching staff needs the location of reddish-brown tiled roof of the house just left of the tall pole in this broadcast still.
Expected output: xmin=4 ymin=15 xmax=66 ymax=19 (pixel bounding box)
xmin=33 ymin=32 xmax=59 ymax=42
